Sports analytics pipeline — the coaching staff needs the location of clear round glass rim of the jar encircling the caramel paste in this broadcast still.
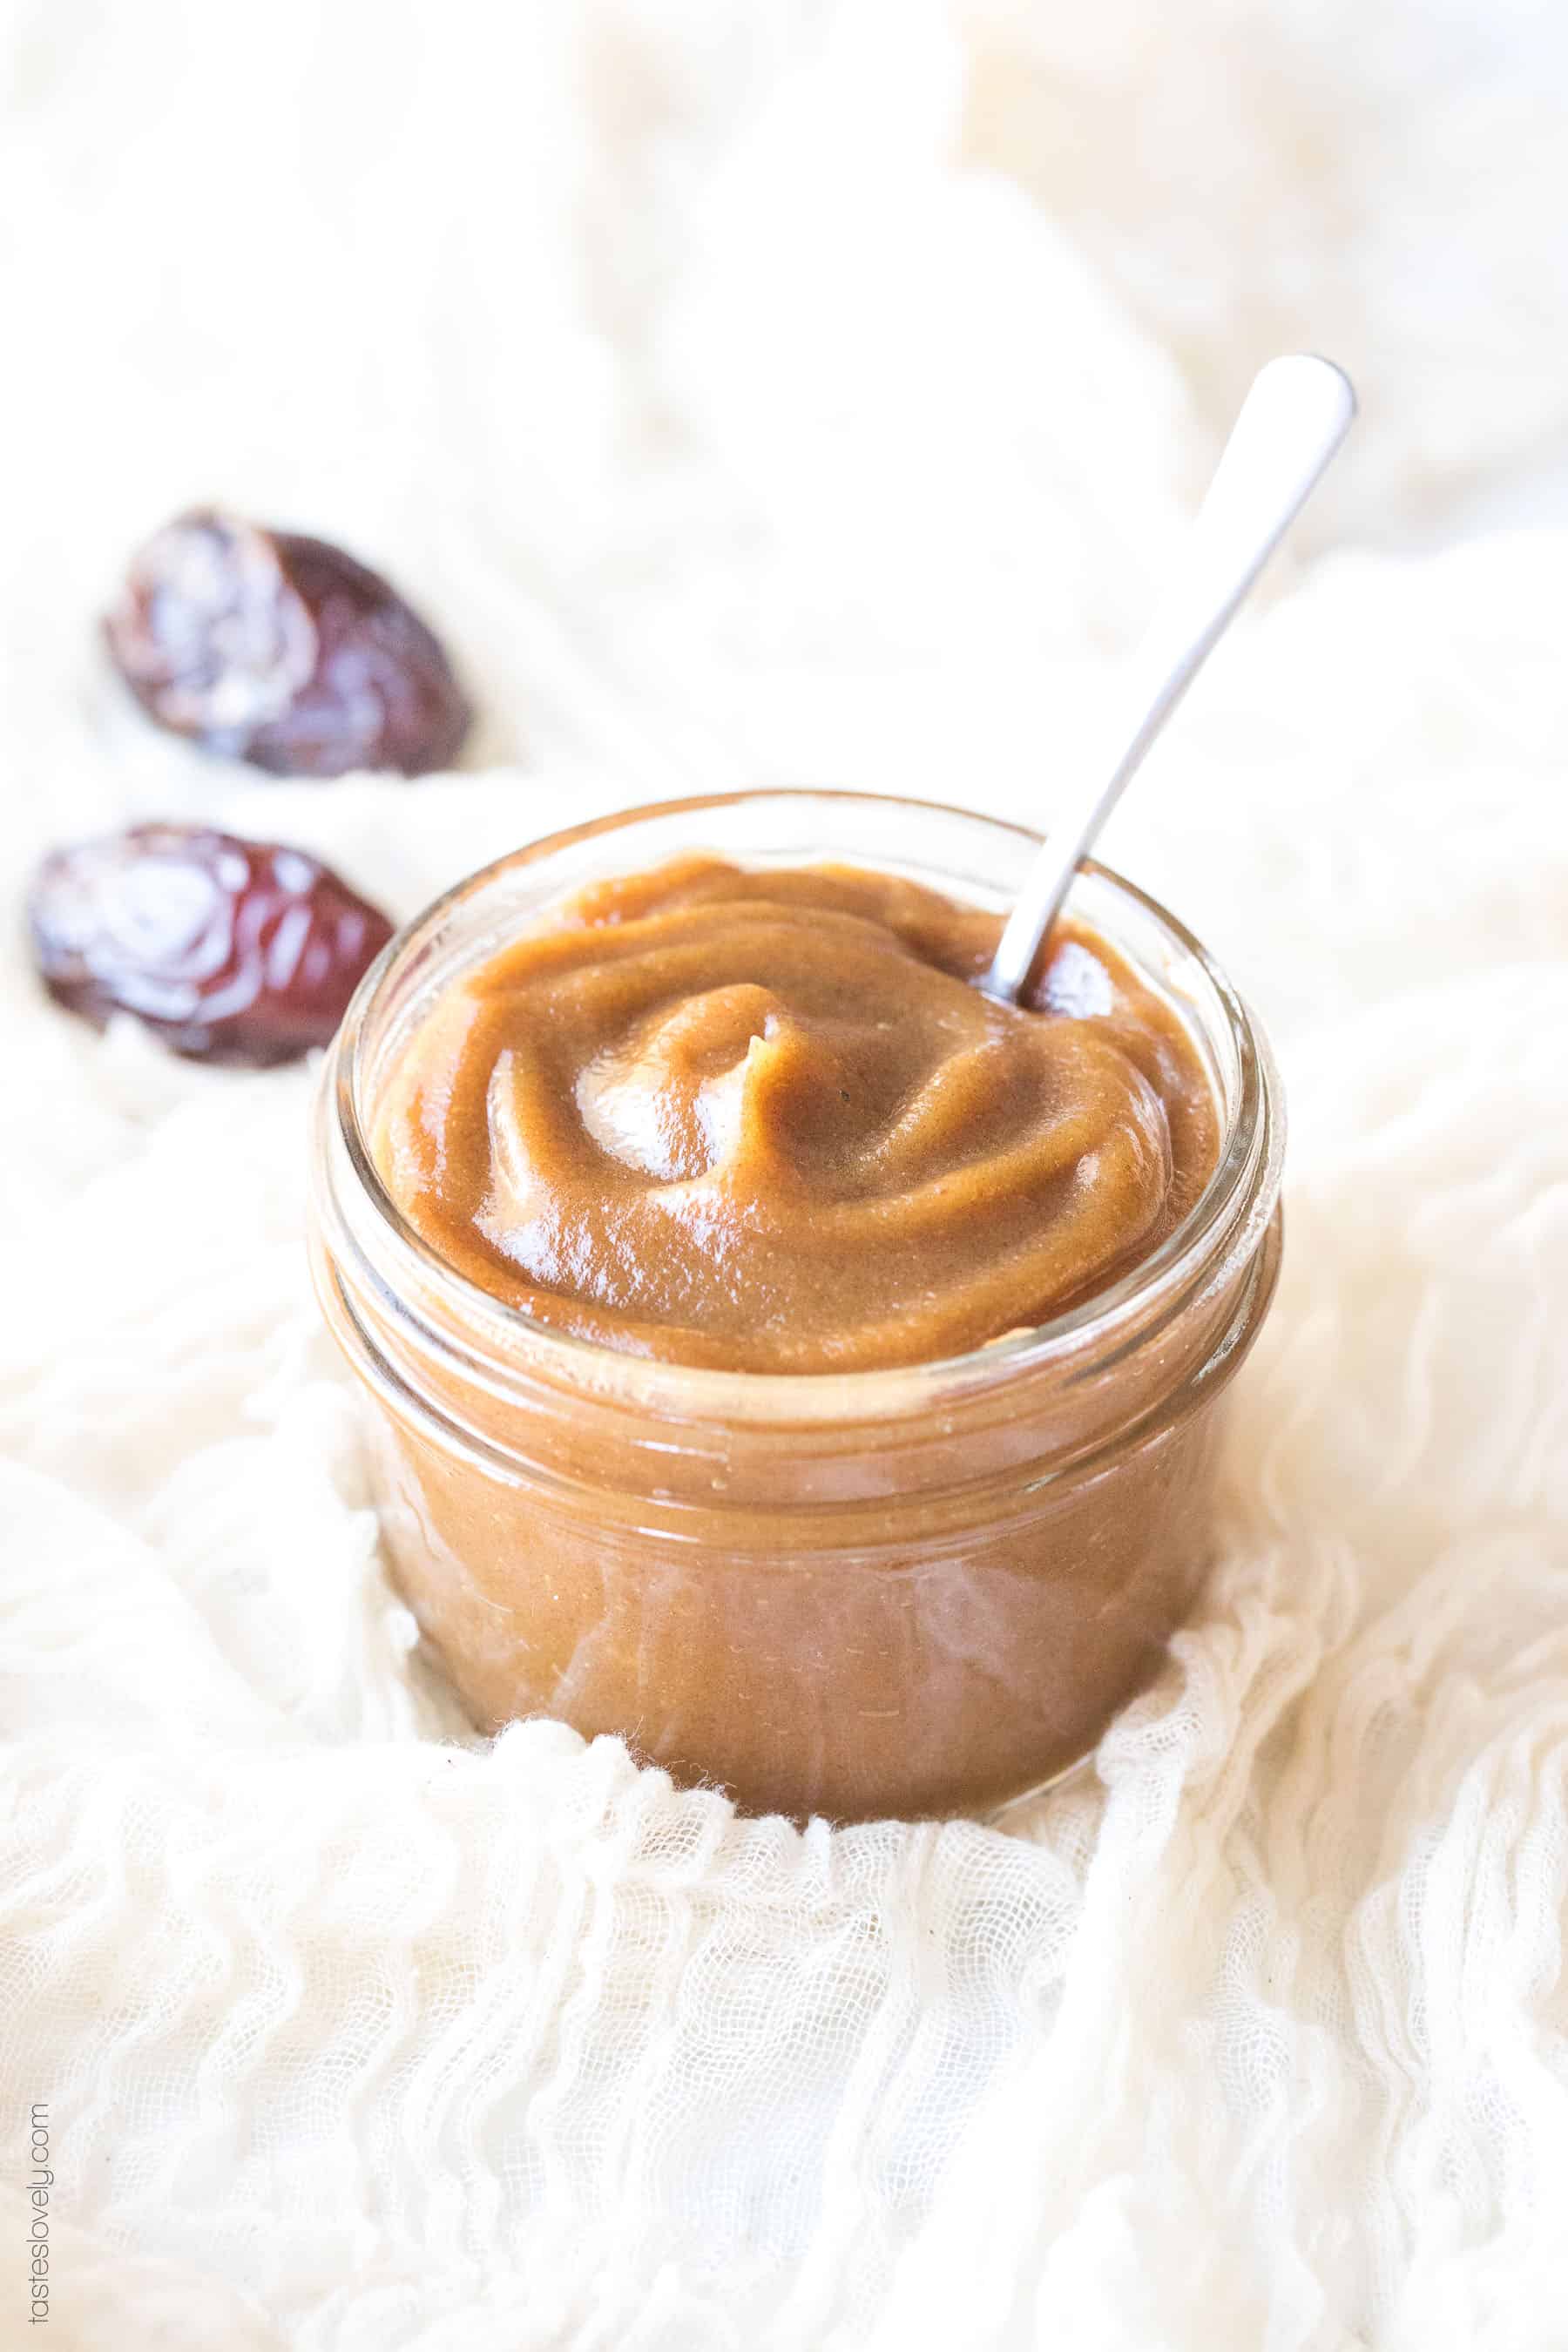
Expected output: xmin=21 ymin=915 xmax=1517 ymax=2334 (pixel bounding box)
xmin=320 ymin=786 xmax=1283 ymax=1425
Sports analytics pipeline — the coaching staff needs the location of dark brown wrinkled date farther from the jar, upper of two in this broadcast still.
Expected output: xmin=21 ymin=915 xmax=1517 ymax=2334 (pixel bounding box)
xmin=104 ymin=510 xmax=470 ymax=776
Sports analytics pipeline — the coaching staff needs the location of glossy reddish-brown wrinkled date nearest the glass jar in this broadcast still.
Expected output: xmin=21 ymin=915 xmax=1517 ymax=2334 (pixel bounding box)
xmin=28 ymin=826 xmax=393 ymax=1068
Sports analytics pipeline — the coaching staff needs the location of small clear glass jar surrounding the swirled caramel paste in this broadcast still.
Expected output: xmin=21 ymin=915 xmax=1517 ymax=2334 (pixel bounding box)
xmin=313 ymin=793 xmax=1281 ymax=1821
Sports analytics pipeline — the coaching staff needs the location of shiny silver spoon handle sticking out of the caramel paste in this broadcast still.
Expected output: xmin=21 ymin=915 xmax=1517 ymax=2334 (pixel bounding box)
xmin=980 ymin=353 xmax=1356 ymax=1002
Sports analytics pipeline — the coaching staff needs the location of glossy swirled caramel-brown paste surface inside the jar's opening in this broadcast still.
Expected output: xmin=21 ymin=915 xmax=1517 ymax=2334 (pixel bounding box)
xmin=376 ymin=859 xmax=1218 ymax=1374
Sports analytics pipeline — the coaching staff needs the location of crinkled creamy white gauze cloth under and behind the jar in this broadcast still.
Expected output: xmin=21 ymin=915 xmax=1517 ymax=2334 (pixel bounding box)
xmin=0 ymin=0 xmax=1568 ymax=2352
